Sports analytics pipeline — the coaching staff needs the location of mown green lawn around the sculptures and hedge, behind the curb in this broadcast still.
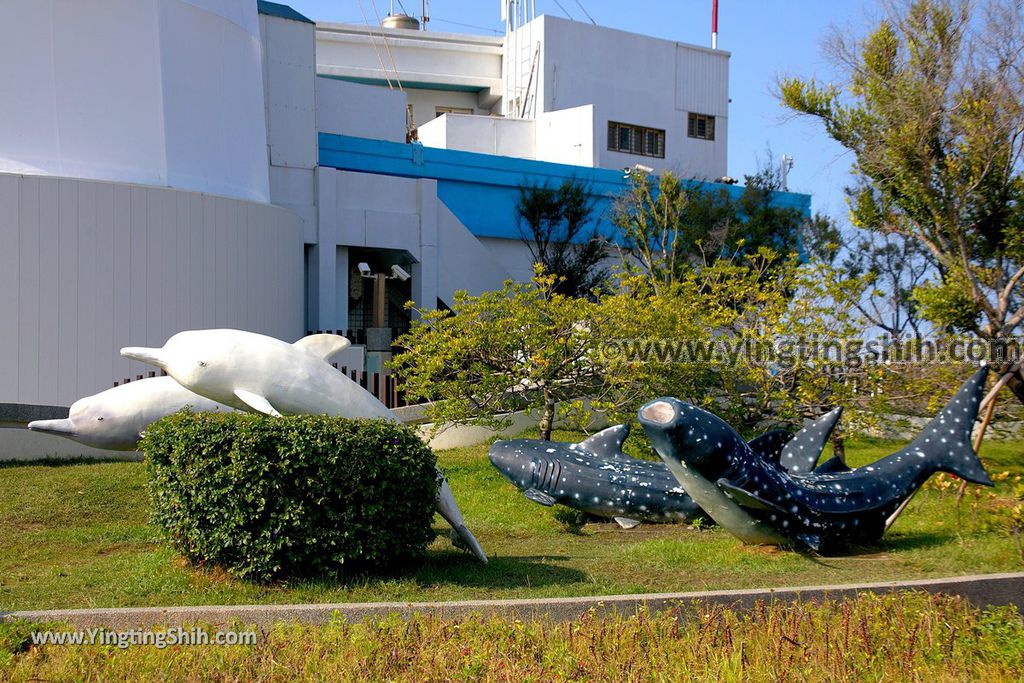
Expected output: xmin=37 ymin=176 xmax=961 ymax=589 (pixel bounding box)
xmin=0 ymin=433 xmax=1024 ymax=610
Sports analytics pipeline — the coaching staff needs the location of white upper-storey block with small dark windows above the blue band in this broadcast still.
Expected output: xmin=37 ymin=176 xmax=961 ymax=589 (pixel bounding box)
xmin=316 ymin=15 xmax=729 ymax=180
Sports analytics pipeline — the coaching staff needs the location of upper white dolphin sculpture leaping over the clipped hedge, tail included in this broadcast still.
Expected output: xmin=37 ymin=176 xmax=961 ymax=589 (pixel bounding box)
xmin=121 ymin=330 xmax=487 ymax=562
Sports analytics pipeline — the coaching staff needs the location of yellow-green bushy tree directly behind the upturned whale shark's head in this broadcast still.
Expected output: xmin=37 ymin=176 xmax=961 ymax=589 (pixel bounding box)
xmin=594 ymin=253 xmax=861 ymax=430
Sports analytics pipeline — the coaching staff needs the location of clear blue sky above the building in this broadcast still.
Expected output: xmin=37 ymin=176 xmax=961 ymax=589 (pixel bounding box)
xmin=285 ymin=0 xmax=880 ymax=224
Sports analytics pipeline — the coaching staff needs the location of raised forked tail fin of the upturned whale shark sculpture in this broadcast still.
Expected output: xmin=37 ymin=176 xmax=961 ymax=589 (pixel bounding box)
xmin=909 ymin=367 xmax=992 ymax=486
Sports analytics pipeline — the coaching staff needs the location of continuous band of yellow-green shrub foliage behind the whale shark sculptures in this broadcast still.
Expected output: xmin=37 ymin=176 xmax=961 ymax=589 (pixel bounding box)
xmin=392 ymin=248 xmax=861 ymax=438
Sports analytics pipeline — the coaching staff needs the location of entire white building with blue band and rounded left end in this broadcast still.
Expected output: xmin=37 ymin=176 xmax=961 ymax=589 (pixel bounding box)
xmin=0 ymin=0 xmax=809 ymax=456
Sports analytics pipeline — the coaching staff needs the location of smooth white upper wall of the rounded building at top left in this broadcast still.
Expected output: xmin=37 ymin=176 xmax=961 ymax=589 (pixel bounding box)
xmin=0 ymin=0 xmax=269 ymax=202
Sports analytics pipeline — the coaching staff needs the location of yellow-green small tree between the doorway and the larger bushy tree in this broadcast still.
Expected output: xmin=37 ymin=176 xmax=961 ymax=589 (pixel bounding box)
xmin=391 ymin=269 xmax=601 ymax=439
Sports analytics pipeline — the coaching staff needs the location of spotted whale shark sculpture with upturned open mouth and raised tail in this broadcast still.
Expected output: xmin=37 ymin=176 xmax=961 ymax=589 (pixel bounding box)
xmin=640 ymin=368 xmax=992 ymax=552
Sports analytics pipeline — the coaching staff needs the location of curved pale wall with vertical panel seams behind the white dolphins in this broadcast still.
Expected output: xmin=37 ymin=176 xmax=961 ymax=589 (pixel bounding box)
xmin=0 ymin=174 xmax=304 ymax=405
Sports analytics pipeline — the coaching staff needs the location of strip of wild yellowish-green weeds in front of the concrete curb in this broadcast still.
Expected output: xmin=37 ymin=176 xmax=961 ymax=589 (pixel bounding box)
xmin=2 ymin=592 xmax=1024 ymax=683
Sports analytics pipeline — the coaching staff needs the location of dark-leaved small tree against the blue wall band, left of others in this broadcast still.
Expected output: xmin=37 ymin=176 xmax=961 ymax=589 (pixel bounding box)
xmin=515 ymin=178 xmax=608 ymax=297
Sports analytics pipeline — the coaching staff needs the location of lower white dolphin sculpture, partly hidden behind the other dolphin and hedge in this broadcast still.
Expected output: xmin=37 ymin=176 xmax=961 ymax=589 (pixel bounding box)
xmin=29 ymin=377 xmax=234 ymax=451
